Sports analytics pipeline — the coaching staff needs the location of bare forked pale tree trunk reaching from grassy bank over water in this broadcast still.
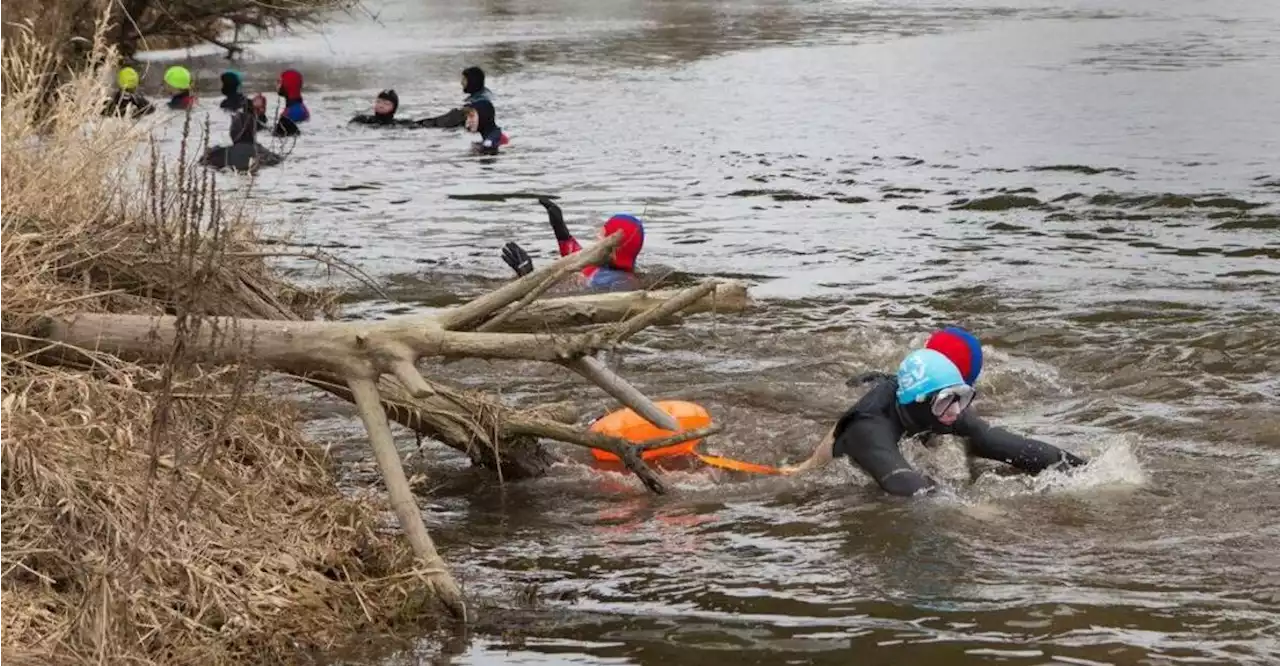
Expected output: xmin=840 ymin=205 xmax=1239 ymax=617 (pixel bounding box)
xmin=15 ymin=234 xmax=747 ymax=619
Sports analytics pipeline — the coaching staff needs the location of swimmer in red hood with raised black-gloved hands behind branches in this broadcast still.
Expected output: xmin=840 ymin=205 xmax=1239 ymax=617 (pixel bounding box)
xmin=502 ymin=197 xmax=644 ymax=291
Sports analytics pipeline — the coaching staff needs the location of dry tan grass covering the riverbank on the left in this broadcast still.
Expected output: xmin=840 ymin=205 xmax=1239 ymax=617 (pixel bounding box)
xmin=0 ymin=12 xmax=445 ymax=665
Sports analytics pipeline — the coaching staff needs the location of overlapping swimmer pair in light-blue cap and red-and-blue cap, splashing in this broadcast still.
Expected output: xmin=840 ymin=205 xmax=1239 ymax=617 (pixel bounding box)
xmin=783 ymin=328 xmax=1087 ymax=496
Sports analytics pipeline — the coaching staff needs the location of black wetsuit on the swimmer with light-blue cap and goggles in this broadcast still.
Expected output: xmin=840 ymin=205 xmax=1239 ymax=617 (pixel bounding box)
xmin=832 ymin=377 xmax=1085 ymax=496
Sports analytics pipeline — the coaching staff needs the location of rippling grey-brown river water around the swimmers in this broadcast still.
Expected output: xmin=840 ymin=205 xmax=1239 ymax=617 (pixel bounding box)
xmin=132 ymin=0 xmax=1280 ymax=666
